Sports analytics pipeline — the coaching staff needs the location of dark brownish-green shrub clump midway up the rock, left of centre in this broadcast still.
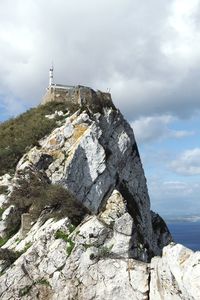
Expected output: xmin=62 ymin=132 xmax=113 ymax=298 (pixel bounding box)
xmin=8 ymin=171 xmax=89 ymax=227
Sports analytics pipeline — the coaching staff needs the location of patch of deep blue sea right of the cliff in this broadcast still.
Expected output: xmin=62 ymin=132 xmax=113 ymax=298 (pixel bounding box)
xmin=166 ymin=221 xmax=200 ymax=251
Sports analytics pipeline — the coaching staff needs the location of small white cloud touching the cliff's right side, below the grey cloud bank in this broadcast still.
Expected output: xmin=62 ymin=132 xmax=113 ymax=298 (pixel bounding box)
xmin=131 ymin=115 xmax=194 ymax=144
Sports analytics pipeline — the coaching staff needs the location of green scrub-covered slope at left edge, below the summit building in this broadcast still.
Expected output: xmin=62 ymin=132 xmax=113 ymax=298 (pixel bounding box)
xmin=0 ymin=102 xmax=71 ymax=176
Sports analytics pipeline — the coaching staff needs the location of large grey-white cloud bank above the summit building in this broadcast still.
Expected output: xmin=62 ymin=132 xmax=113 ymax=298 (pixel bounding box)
xmin=0 ymin=0 xmax=200 ymax=120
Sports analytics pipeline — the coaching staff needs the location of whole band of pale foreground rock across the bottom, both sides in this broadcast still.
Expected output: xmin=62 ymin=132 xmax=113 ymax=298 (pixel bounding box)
xmin=0 ymin=213 xmax=200 ymax=300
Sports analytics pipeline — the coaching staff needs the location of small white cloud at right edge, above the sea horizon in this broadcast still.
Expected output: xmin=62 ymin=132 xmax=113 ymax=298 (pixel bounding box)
xmin=170 ymin=148 xmax=200 ymax=176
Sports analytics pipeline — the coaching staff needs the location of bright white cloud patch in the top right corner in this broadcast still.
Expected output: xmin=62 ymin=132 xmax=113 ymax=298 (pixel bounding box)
xmin=162 ymin=0 xmax=200 ymax=68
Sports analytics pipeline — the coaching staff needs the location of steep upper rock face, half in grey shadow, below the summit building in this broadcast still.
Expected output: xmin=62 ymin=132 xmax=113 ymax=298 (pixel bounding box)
xmin=13 ymin=107 xmax=171 ymax=261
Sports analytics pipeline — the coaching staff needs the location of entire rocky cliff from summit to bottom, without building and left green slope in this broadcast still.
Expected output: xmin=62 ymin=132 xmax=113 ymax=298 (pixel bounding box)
xmin=0 ymin=86 xmax=200 ymax=300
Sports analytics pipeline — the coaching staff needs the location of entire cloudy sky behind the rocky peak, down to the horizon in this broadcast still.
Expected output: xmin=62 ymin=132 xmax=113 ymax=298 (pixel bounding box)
xmin=0 ymin=0 xmax=200 ymax=216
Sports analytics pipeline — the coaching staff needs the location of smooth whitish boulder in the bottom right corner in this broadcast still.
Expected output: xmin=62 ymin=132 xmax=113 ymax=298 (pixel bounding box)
xmin=150 ymin=244 xmax=200 ymax=300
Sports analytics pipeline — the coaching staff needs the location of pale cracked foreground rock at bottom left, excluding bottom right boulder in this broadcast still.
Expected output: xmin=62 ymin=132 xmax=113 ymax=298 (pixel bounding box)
xmin=0 ymin=216 xmax=149 ymax=300
